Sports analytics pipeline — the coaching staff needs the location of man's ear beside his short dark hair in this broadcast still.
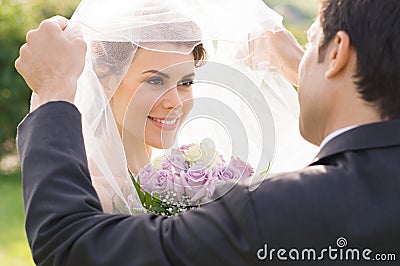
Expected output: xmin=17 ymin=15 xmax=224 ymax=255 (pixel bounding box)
xmin=325 ymin=31 xmax=353 ymax=78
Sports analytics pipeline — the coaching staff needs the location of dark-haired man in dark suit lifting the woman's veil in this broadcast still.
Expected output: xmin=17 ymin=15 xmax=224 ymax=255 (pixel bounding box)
xmin=16 ymin=0 xmax=400 ymax=266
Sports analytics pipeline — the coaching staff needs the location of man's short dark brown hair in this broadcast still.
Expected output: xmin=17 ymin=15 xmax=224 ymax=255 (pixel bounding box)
xmin=319 ymin=0 xmax=400 ymax=119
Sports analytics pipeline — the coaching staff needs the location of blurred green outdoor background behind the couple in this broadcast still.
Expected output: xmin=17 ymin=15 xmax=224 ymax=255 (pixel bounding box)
xmin=0 ymin=0 xmax=317 ymax=266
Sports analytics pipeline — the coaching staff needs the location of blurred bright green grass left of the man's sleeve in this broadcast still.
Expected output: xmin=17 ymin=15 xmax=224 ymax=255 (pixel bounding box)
xmin=0 ymin=172 xmax=35 ymax=266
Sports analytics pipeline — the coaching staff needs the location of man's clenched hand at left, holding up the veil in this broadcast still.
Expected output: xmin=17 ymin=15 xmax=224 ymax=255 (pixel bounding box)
xmin=15 ymin=16 xmax=86 ymax=105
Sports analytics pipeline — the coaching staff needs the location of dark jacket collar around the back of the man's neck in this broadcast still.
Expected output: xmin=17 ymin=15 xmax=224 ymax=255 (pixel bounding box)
xmin=312 ymin=120 xmax=400 ymax=165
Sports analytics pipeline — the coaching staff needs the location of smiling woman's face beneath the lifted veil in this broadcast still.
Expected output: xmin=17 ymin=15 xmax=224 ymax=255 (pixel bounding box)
xmin=111 ymin=49 xmax=194 ymax=149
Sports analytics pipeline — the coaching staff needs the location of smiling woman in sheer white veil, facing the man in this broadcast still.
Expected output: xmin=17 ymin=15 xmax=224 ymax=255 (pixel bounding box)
xmin=43 ymin=0 xmax=314 ymax=214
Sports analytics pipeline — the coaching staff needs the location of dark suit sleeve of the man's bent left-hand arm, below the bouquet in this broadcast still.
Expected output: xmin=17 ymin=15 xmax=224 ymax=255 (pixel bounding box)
xmin=17 ymin=102 xmax=259 ymax=266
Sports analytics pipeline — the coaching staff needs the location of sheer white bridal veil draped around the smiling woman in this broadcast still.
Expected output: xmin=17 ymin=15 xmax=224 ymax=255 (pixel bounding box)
xmin=61 ymin=0 xmax=316 ymax=214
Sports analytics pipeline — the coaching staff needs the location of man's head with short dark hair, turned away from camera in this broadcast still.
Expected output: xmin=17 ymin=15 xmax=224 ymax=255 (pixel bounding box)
xmin=299 ymin=0 xmax=400 ymax=145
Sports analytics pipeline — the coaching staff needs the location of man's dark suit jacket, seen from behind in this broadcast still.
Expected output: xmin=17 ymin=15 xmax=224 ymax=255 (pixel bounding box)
xmin=17 ymin=102 xmax=400 ymax=266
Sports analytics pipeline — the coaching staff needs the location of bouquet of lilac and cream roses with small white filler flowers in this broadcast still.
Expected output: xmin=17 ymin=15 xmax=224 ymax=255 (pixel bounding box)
xmin=132 ymin=139 xmax=254 ymax=216
